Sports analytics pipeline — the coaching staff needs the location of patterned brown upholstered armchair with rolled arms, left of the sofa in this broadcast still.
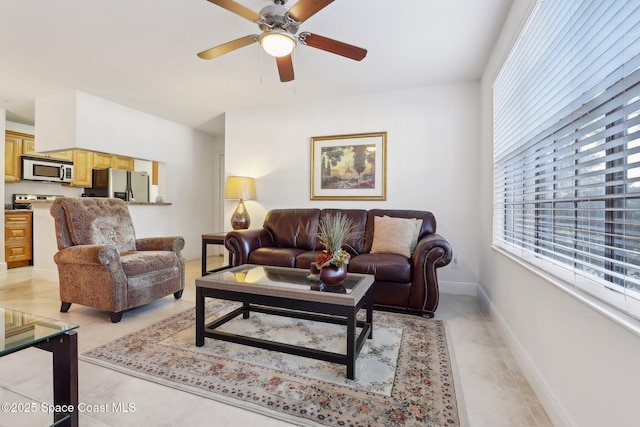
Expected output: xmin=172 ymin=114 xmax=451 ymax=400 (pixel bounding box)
xmin=51 ymin=197 xmax=185 ymax=323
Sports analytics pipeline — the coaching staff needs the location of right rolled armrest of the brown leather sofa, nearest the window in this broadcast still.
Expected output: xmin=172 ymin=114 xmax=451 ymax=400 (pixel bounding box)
xmin=409 ymin=233 xmax=453 ymax=313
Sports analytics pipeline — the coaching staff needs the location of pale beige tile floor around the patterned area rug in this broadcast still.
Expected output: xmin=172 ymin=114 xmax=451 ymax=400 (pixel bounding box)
xmin=0 ymin=257 xmax=552 ymax=427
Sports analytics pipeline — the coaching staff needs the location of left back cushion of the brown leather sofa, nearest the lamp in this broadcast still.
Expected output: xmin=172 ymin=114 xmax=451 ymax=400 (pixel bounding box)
xmin=263 ymin=209 xmax=320 ymax=251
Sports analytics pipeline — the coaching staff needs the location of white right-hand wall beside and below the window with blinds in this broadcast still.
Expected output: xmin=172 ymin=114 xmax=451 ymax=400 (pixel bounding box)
xmin=478 ymin=0 xmax=640 ymax=427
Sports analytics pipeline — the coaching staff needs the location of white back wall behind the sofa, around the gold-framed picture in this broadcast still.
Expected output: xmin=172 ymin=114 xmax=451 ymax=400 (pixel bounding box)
xmin=225 ymin=83 xmax=479 ymax=292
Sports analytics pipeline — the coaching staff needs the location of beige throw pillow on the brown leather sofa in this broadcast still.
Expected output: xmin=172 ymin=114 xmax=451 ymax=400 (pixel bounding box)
xmin=371 ymin=216 xmax=422 ymax=258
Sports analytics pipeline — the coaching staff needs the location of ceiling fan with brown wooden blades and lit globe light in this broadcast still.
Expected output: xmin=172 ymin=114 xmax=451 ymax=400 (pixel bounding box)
xmin=198 ymin=0 xmax=367 ymax=82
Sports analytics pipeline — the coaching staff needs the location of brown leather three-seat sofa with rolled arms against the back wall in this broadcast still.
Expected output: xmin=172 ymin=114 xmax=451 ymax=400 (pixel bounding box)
xmin=225 ymin=209 xmax=453 ymax=317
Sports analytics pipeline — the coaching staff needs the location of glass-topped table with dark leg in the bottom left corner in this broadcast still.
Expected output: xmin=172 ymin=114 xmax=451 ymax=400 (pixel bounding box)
xmin=0 ymin=307 xmax=78 ymax=427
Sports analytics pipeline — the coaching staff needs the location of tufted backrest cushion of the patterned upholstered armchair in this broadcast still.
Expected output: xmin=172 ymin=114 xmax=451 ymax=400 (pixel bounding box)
xmin=59 ymin=197 xmax=136 ymax=252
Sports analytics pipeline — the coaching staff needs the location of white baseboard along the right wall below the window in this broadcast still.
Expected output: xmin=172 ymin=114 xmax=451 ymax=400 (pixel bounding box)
xmin=478 ymin=286 xmax=574 ymax=427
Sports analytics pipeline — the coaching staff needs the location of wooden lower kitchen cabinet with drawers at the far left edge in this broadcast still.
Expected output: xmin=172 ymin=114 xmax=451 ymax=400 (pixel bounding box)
xmin=4 ymin=211 xmax=33 ymax=268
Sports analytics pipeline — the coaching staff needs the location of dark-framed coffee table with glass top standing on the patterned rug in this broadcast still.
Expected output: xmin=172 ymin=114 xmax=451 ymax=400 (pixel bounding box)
xmin=196 ymin=264 xmax=373 ymax=379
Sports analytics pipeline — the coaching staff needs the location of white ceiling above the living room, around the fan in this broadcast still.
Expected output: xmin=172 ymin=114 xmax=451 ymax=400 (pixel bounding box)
xmin=0 ymin=0 xmax=512 ymax=133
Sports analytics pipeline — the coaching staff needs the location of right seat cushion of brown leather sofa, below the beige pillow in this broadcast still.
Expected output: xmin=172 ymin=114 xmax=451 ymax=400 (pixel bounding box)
xmin=348 ymin=253 xmax=411 ymax=283
